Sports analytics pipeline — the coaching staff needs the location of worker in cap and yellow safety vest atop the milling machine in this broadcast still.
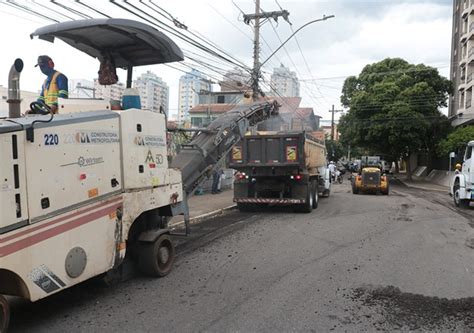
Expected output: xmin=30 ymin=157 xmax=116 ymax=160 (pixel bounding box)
xmin=35 ymin=55 xmax=68 ymax=113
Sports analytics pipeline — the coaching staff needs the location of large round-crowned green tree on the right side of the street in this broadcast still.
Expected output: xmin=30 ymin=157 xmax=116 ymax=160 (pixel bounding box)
xmin=339 ymin=58 xmax=452 ymax=179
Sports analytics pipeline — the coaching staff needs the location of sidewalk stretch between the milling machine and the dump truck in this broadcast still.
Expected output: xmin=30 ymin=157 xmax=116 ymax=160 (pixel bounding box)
xmin=169 ymin=190 xmax=236 ymax=226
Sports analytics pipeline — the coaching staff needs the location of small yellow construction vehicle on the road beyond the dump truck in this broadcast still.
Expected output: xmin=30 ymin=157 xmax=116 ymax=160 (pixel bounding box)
xmin=352 ymin=156 xmax=390 ymax=195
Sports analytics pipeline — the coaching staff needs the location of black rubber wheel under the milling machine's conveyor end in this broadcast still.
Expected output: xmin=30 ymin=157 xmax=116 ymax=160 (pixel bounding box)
xmin=138 ymin=234 xmax=176 ymax=277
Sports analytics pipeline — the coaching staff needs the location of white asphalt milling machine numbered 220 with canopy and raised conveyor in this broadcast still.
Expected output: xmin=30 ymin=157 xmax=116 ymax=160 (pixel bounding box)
xmin=0 ymin=19 xmax=278 ymax=332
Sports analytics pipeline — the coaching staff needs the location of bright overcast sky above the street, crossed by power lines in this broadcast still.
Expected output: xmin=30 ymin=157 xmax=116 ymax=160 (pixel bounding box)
xmin=0 ymin=0 xmax=452 ymax=119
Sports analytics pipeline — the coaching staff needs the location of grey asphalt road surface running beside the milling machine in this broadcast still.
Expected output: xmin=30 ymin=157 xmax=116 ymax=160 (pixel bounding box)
xmin=7 ymin=182 xmax=474 ymax=332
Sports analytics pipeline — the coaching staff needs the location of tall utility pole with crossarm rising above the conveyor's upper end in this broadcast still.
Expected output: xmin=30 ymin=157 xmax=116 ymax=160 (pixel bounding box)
xmin=244 ymin=0 xmax=290 ymax=101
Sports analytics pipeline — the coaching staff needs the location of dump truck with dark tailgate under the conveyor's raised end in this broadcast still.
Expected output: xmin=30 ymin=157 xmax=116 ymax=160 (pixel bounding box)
xmin=229 ymin=131 xmax=331 ymax=213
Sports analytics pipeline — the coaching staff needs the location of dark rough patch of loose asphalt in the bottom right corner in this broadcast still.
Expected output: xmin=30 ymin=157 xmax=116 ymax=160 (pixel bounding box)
xmin=350 ymin=286 xmax=474 ymax=331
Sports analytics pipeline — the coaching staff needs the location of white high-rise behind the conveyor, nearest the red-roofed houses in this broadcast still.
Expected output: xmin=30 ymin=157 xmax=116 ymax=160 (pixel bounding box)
xmin=177 ymin=69 xmax=212 ymax=123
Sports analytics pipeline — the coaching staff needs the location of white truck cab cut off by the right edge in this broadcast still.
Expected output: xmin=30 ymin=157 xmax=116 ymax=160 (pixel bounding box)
xmin=449 ymin=140 xmax=474 ymax=207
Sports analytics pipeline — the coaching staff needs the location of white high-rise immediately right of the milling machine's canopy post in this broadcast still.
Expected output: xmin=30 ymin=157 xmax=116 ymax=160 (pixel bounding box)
xmin=133 ymin=71 xmax=169 ymax=114
